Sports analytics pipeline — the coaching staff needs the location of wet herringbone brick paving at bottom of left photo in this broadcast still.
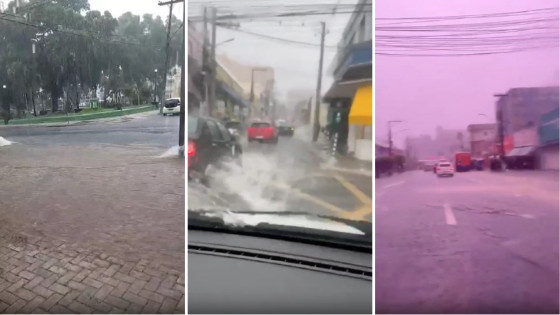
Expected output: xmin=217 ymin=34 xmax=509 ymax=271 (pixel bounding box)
xmin=0 ymin=228 xmax=185 ymax=314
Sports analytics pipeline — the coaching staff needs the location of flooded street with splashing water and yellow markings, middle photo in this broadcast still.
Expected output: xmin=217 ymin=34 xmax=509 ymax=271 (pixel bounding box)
xmin=188 ymin=130 xmax=372 ymax=221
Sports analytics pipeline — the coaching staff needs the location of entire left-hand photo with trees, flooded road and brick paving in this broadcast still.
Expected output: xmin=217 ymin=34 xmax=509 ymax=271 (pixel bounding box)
xmin=0 ymin=0 xmax=187 ymax=314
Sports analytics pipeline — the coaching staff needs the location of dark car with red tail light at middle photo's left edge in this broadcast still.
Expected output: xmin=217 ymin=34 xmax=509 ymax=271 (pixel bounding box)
xmin=187 ymin=115 xmax=243 ymax=181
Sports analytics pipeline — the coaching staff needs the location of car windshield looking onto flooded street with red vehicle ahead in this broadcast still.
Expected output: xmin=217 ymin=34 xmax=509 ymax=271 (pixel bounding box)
xmin=188 ymin=0 xmax=372 ymax=248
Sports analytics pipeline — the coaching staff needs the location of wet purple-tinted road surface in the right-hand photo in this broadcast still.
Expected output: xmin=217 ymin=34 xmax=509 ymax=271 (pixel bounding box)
xmin=375 ymin=171 xmax=559 ymax=314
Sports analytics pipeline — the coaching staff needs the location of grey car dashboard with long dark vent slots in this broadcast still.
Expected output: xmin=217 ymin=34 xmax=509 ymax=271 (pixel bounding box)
xmin=188 ymin=230 xmax=372 ymax=314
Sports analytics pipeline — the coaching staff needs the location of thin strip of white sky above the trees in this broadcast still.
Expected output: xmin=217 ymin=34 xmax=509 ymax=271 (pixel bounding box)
xmin=89 ymin=0 xmax=183 ymax=21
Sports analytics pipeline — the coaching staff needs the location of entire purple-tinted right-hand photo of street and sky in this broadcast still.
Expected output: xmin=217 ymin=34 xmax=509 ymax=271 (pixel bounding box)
xmin=375 ymin=0 xmax=560 ymax=314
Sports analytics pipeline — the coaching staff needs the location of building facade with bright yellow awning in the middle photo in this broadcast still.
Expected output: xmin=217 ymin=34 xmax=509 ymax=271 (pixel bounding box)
xmin=323 ymin=0 xmax=373 ymax=160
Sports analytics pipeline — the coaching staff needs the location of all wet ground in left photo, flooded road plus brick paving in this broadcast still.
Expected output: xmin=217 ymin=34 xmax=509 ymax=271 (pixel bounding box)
xmin=0 ymin=111 xmax=185 ymax=313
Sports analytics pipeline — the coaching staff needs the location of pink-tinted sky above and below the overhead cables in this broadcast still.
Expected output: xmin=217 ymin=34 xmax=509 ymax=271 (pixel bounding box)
xmin=375 ymin=0 xmax=559 ymax=146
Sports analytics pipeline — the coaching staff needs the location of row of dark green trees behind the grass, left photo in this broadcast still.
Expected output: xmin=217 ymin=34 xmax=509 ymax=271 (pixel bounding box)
xmin=0 ymin=0 xmax=183 ymax=117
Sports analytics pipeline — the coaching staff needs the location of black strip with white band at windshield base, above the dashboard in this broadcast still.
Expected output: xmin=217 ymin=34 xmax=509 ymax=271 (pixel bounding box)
xmin=188 ymin=210 xmax=372 ymax=253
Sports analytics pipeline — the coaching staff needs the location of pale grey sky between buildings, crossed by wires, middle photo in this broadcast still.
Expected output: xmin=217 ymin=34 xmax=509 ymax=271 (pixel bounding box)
xmin=188 ymin=0 xmax=357 ymax=101
